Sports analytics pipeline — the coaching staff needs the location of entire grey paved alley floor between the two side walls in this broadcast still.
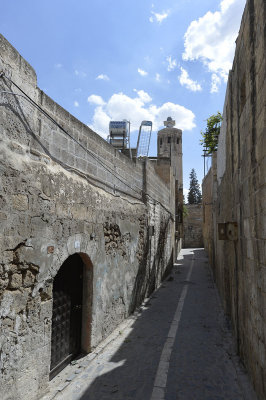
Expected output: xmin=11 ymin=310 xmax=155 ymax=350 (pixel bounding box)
xmin=43 ymin=249 xmax=257 ymax=400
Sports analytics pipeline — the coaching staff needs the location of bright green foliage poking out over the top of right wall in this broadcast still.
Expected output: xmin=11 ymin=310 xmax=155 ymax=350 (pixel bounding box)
xmin=200 ymin=111 xmax=223 ymax=154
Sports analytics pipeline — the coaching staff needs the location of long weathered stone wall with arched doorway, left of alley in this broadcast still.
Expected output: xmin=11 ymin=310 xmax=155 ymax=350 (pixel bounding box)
xmin=0 ymin=36 xmax=179 ymax=400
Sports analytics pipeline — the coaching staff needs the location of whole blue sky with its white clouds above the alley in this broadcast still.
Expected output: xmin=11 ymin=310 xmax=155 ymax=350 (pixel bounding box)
xmin=0 ymin=0 xmax=245 ymax=197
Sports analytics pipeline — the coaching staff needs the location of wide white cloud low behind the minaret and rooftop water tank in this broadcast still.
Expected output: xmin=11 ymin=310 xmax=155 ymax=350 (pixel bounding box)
xmin=89 ymin=90 xmax=196 ymax=138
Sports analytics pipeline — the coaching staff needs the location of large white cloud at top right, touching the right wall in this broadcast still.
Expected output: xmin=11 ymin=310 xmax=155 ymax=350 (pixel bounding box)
xmin=183 ymin=0 xmax=246 ymax=81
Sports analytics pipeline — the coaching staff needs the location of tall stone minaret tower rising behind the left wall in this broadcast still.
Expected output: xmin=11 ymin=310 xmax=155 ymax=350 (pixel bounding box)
xmin=157 ymin=117 xmax=183 ymax=189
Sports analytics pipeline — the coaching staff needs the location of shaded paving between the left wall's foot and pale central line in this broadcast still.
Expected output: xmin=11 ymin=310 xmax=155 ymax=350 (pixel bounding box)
xmin=79 ymin=250 xmax=205 ymax=400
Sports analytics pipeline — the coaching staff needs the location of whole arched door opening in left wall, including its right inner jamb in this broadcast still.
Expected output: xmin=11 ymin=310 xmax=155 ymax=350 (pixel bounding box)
xmin=50 ymin=253 xmax=93 ymax=379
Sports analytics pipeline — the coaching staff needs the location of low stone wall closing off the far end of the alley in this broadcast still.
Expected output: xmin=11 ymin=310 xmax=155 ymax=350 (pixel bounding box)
xmin=183 ymin=204 xmax=203 ymax=248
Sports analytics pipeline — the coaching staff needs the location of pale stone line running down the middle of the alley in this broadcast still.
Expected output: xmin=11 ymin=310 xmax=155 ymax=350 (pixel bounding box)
xmin=150 ymin=258 xmax=194 ymax=400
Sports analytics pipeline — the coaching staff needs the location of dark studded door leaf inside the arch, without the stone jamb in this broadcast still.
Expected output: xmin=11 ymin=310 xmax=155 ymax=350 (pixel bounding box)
xmin=50 ymin=254 xmax=83 ymax=380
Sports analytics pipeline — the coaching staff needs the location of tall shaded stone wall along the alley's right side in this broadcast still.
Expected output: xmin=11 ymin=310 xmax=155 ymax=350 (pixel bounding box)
xmin=203 ymin=0 xmax=266 ymax=399
